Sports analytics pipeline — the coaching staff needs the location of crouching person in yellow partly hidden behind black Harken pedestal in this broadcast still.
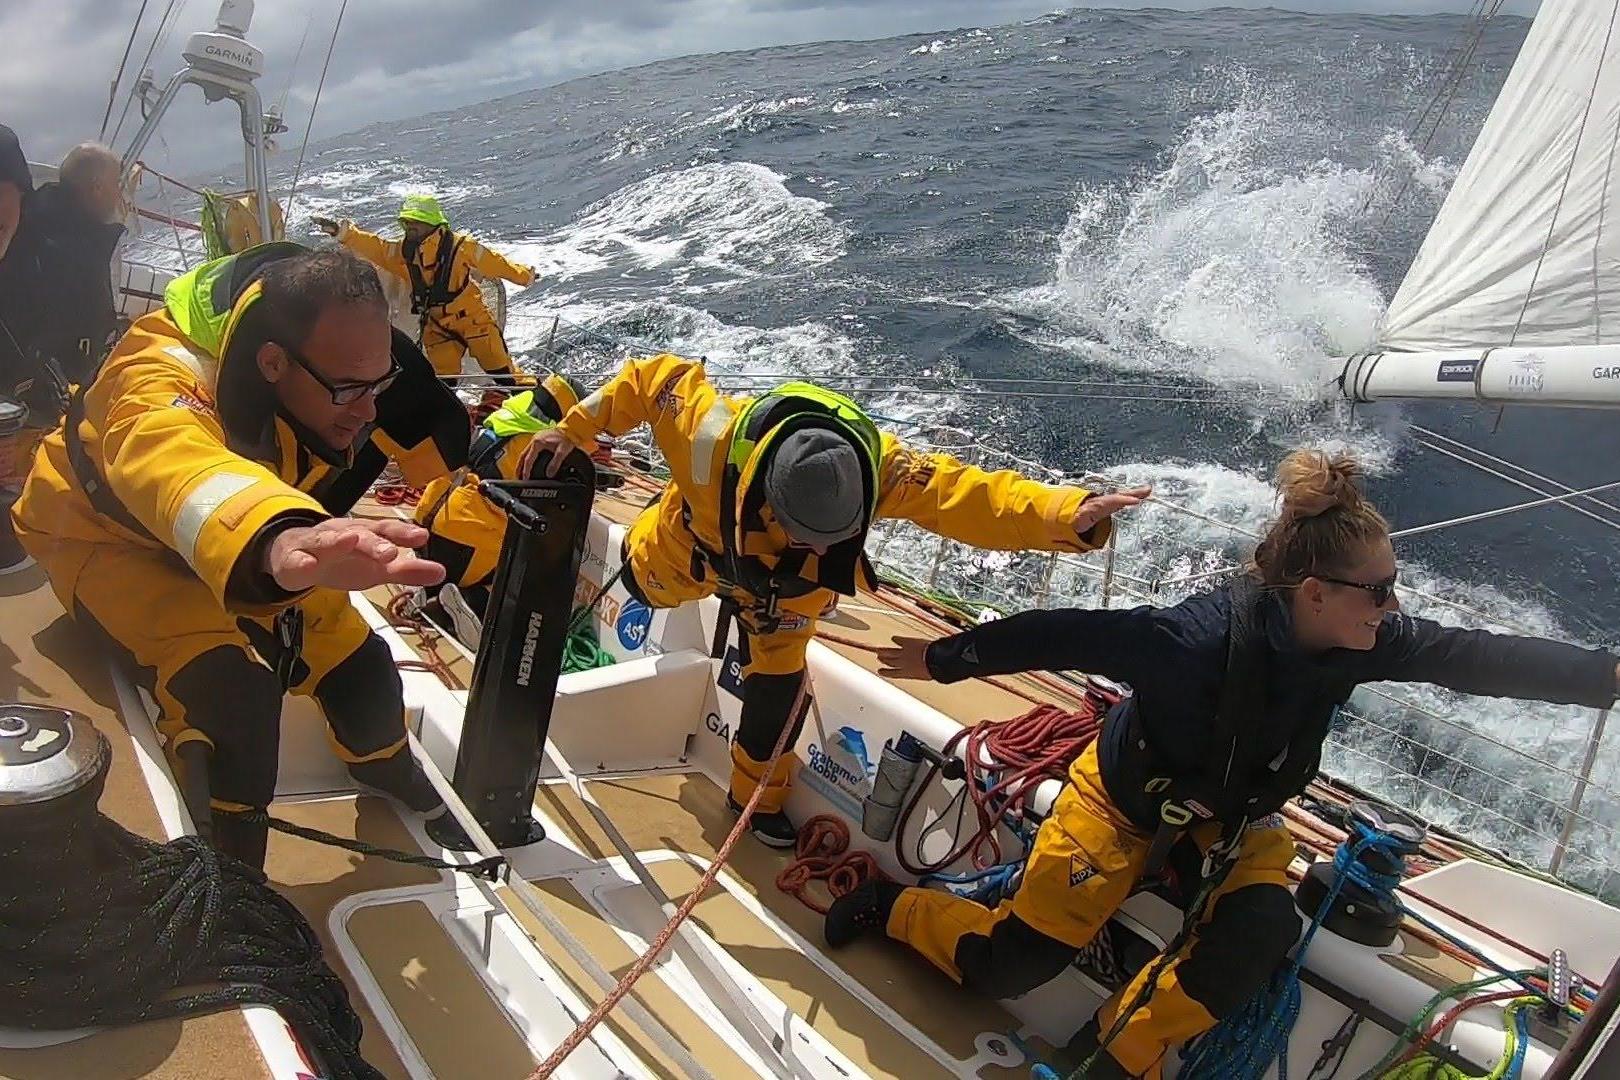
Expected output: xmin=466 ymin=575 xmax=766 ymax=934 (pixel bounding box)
xmin=416 ymin=374 xmax=585 ymax=651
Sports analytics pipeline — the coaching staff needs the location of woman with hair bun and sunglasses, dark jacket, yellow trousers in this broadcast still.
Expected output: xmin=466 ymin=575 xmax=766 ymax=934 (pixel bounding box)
xmin=825 ymin=450 xmax=1620 ymax=1078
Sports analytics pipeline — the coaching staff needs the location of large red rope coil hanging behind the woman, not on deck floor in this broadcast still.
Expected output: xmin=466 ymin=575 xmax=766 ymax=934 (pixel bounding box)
xmin=894 ymin=687 xmax=1118 ymax=876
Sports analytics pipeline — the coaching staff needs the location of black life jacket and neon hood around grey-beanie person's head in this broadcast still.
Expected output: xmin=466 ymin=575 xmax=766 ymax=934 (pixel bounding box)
xmin=684 ymin=382 xmax=883 ymax=619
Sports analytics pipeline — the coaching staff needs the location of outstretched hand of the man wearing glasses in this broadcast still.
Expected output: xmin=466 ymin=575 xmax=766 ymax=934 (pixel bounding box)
xmin=264 ymin=518 xmax=444 ymax=593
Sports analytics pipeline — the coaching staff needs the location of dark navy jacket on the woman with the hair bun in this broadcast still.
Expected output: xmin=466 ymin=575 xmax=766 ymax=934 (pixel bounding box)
xmin=928 ymin=588 xmax=1617 ymax=829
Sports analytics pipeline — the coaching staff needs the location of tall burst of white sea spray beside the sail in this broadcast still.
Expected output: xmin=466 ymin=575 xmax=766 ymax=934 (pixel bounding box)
xmin=1003 ymin=79 xmax=1452 ymax=395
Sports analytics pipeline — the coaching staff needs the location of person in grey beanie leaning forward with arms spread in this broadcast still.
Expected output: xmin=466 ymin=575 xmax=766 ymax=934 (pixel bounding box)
xmin=522 ymin=355 xmax=1149 ymax=847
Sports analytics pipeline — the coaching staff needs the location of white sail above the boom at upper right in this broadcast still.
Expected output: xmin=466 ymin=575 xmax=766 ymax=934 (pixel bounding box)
xmin=1379 ymin=0 xmax=1620 ymax=350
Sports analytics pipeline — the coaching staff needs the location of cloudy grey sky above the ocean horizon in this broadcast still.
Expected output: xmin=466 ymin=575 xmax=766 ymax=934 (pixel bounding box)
xmin=0 ymin=0 xmax=1537 ymax=168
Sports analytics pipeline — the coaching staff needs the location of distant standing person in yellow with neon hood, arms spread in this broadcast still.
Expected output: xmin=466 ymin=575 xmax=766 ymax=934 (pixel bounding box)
xmin=313 ymin=194 xmax=535 ymax=382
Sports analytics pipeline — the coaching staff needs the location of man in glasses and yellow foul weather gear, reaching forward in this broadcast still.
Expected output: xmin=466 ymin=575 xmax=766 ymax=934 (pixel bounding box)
xmin=13 ymin=243 xmax=468 ymax=865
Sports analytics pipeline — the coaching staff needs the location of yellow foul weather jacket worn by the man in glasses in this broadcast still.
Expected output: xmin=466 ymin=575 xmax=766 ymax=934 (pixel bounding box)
xmin=13 ymin=244 xmax=467 ymax=615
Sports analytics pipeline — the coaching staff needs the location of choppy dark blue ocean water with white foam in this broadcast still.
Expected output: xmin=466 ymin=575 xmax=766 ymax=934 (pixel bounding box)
xmin=142 ymin=10 xmax=1620 ymax=895
